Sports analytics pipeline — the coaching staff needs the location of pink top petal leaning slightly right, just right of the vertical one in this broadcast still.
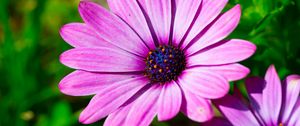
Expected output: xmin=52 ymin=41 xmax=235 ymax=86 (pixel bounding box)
xmin=172 ymin=0 xmax=202 ymax=45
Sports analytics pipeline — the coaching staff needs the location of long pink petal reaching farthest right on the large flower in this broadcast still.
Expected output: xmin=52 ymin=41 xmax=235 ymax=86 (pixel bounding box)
xmin=187 ymin=39 xmax=256 ymax=66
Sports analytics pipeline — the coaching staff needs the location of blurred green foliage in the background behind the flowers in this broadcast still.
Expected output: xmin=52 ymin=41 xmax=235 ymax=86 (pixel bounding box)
xmin=0 ymin=0 xmax=300 ymax=126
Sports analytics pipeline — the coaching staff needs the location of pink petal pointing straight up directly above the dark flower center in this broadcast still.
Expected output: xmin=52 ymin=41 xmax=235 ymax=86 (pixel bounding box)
xmin=138 ymin=0 xmax=172 ymax=45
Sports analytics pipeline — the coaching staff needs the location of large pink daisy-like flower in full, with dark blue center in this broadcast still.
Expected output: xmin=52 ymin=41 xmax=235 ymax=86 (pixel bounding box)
xmin=59 ymin=0 xmax=256 ymax=126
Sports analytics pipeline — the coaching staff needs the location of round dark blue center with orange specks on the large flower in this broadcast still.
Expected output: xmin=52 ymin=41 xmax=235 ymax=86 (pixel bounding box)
xmin=145 ymin=45 xmax=186 ymax=83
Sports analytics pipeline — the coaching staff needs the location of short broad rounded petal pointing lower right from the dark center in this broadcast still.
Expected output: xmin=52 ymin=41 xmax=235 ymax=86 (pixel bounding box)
xmin=178 ymin=68 xmax=229 ymax=99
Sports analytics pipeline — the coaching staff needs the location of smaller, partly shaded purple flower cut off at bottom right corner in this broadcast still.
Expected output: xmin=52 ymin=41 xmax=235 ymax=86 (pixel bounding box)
xmin=216 ymin=65 xmax=300 ymax=126
